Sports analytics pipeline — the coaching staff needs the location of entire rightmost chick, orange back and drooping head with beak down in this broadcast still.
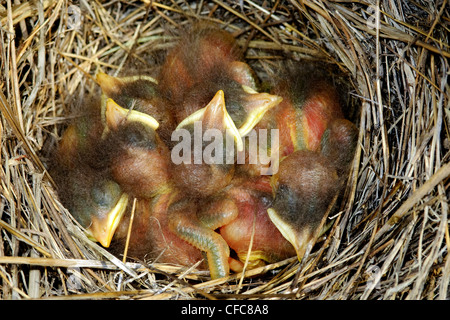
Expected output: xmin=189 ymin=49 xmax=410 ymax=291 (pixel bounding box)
xmin=260 ymin=64 xmax=357 ymax=260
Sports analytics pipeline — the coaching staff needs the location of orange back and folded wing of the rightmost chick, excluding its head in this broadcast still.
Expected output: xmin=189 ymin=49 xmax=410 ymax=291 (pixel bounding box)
xmin=268 ymin=63 xmax=357 ymax=175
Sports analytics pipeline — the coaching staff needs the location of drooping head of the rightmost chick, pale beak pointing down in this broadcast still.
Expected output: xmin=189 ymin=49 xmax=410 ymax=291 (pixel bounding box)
xmin=267 ymin=150 xmax=340 ymax=260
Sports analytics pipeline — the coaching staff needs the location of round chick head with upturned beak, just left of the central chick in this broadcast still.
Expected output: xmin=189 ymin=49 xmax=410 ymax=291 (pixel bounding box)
xmin=100 ymin=98 xmax=170 ymax=198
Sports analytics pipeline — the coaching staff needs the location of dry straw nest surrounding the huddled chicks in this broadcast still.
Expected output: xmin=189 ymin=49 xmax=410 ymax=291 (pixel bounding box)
xmin=0 ymin=0 xmax=450 ymax=299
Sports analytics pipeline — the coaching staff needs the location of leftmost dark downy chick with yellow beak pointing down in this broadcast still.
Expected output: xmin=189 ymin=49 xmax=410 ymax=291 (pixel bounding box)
xmin=50 ymin=101 xmax=128 ymax=247
